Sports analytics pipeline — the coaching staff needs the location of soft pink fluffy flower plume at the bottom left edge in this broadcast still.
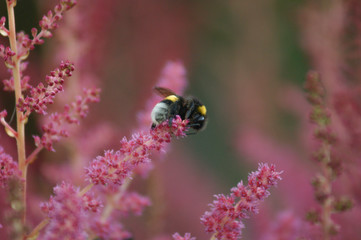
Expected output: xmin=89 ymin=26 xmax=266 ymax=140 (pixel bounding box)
xmin=40 ymin=182 xmax=101 ymax=239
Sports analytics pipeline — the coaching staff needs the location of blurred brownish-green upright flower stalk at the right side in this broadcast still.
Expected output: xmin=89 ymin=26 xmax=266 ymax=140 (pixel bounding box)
xmin=305 ymin=71 xmax=339 ymax=240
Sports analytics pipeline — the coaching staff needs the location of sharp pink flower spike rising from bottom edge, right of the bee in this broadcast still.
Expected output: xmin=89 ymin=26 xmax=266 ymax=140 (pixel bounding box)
xmin=201 ymin=164 xmax=282 ymax=239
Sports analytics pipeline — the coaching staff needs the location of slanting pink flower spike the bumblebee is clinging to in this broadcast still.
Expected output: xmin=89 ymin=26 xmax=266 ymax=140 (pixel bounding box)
xmin=86 ymin=116 xmax=188 ymax=185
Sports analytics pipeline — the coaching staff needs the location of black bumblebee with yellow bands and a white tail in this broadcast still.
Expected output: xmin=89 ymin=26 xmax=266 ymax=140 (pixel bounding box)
xmin=151 ymin=87 xmax=207 ymax=134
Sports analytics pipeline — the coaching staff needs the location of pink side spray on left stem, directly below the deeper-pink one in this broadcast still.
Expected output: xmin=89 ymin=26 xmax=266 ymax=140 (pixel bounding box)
xmin=34 ymin=88 xmax=100 ymax=151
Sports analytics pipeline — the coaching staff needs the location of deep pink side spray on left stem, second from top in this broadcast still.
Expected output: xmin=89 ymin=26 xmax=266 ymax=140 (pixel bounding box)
xmin=17 ymin=62 xmax=74 ymax=117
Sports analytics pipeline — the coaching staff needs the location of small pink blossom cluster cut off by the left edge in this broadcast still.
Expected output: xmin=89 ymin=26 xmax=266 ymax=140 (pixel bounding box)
xmin=0 ymin=146 xmax=20 ymax=187
